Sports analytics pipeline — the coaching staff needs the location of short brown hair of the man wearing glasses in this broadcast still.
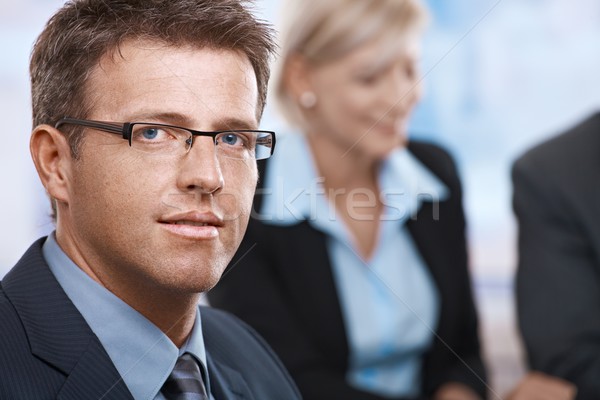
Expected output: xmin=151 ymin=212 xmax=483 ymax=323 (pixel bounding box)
xmin=30 ymin=0 xmax=275 ymax=157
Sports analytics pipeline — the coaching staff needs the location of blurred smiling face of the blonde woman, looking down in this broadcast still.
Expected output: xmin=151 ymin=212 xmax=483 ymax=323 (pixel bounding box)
xmin=306 ymin=38 xmax=421 ymax=159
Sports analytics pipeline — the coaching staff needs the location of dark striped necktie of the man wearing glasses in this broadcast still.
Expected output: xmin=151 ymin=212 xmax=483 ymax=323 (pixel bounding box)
xmin=161 ymin=353 xmax=209 ymax=400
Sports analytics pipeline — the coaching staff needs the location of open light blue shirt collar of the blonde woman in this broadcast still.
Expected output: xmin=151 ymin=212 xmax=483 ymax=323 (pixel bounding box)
xmin=257 ymin=133 xmax=448 ymax=226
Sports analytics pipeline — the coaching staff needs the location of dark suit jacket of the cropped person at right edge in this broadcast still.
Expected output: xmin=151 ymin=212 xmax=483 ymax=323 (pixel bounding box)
xmin=513 ymin=114 xmax=600 ymax=400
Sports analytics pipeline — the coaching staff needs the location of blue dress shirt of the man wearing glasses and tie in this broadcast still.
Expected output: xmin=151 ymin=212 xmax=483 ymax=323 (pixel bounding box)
xmin=42 ymin=233 xmax=212 ymax=400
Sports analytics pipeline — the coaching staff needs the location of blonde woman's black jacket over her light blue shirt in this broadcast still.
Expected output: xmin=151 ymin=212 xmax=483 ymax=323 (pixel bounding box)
xmin=208 ymin=143 xmax=485 ymax=400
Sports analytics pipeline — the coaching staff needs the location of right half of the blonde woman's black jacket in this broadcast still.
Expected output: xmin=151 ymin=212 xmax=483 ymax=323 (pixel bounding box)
xmin=411 ymin=143 xmax=487 ymax=398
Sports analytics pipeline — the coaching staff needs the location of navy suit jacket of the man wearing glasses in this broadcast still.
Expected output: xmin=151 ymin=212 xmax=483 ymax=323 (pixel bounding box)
xmin=0 ymin=239 xmax=300 ymax=400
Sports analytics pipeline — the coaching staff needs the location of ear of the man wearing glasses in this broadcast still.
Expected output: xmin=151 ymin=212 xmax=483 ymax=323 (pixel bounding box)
xmin=29 ymin=125 xmax=75 ymax=203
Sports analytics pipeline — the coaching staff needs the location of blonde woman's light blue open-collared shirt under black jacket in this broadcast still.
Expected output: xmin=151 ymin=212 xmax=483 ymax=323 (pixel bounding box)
xmin=258 ymin=134 xmax=447 ymax=397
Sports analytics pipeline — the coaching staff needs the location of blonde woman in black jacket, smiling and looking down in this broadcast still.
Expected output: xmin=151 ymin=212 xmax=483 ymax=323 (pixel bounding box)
xmin=209 ymin=0 xmax=486 ymax=400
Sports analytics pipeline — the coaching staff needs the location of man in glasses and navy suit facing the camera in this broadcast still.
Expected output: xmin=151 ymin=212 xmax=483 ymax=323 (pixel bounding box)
xmin=0 ymin=0 xmax=299 ymax=400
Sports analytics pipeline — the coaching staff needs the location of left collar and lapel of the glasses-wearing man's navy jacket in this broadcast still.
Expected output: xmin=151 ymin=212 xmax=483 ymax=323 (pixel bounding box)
xmin=2 ymin=239 xmax=132 ymax=400
